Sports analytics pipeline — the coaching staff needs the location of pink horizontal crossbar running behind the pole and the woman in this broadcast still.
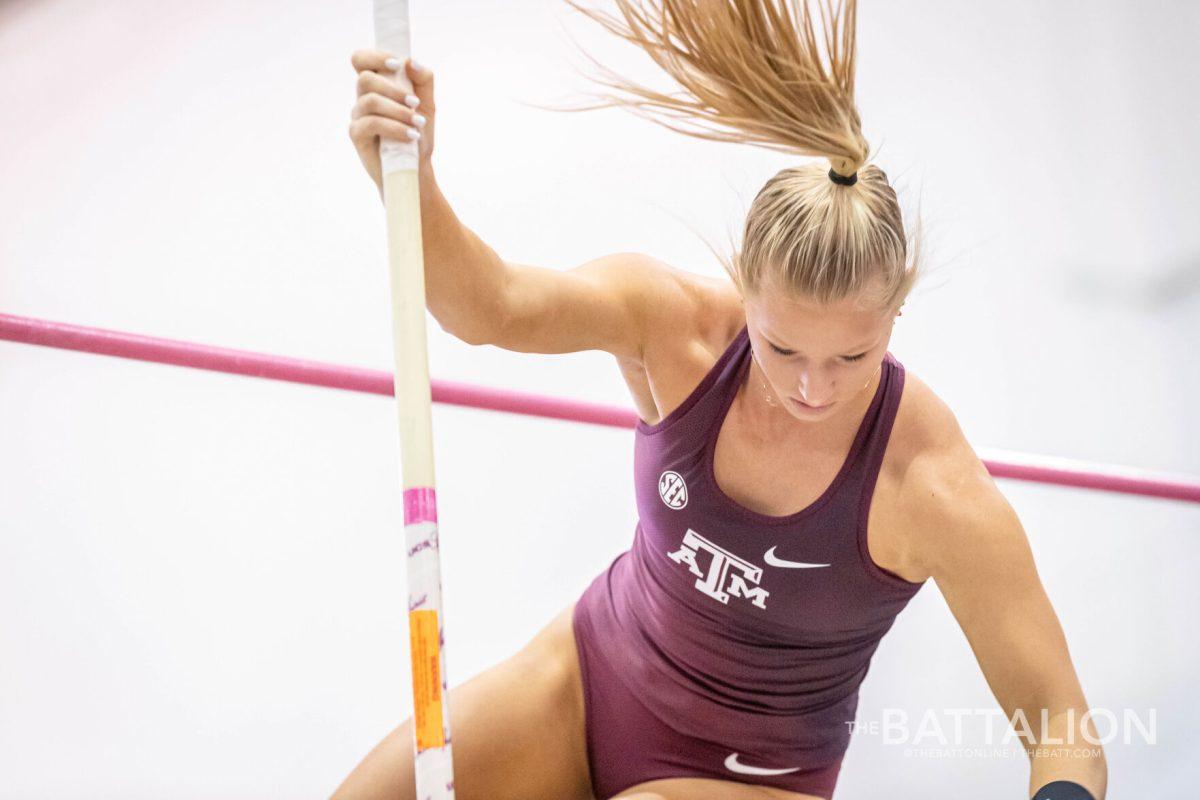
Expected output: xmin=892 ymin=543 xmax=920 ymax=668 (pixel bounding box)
xmin=0 ymin=314 xmax=1200 ymax=503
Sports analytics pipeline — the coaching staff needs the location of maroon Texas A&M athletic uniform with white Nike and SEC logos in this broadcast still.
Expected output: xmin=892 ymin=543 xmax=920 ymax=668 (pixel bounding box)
xmin=574 ymin=327 xmax=923 ymax=798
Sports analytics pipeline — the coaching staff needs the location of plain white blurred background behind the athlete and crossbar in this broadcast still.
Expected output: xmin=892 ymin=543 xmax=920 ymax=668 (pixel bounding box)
xmin=0 ymin=0 xmax=1200 ymax=798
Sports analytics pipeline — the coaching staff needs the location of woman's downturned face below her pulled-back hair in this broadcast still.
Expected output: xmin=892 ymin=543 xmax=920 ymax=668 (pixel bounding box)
xmin=744 ymin=278 xmax=896 ymax=421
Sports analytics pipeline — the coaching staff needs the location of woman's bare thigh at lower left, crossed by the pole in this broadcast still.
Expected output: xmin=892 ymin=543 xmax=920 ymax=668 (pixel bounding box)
xmin=334 ymin=602 xmax=592 ymax=800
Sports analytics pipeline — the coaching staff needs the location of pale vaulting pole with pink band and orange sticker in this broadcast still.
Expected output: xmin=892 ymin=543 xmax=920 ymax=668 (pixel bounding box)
xmin=374 ymin=0 xmax=455 ymax=800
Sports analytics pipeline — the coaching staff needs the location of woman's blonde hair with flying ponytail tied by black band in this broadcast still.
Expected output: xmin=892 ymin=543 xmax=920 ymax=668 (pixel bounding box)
xmin=566 ymin=0 xmax=920 ymax=308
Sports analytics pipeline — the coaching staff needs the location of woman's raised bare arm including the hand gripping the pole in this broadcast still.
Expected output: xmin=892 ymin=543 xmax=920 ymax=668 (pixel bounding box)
xmin=349 ymin=50 xmax=697 ymax=361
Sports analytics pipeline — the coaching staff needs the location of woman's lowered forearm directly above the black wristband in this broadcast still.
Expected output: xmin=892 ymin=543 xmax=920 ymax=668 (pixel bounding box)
xmin=1026 ymin=706 xmax=1108 ymax=800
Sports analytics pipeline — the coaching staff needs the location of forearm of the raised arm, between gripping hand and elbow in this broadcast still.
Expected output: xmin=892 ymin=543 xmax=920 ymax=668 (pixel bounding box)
xmin=384 ymin=163 xmax=508 ymax=344
